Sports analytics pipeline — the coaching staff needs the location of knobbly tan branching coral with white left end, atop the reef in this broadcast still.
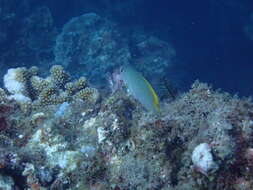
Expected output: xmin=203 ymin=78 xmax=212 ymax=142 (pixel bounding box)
xmin=0 ymin=65 xmax=99 ymax=112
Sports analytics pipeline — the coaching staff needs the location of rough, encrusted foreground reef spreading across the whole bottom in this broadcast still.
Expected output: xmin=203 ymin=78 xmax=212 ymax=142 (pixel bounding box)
xmin=0 ymin=65 xmax=253 ymax=190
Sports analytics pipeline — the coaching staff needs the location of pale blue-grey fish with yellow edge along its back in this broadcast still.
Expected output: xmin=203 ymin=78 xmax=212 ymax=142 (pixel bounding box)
xmin=119 ymin=65 xmax=160 ymax=113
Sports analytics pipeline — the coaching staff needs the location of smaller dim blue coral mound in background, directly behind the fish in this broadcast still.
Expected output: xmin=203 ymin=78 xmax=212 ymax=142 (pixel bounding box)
xmin=130 ymin=33 xmax=178 ymax=98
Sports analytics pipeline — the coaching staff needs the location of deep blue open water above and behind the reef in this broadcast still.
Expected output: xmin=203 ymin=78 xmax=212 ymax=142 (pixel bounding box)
xmin=0 ymin=0 xmax=253 ymax=96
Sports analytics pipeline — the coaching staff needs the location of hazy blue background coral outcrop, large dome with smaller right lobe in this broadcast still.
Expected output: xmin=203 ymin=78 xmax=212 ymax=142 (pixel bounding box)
xmin=54 ymin=13 xmax=176 ymax=90
